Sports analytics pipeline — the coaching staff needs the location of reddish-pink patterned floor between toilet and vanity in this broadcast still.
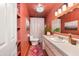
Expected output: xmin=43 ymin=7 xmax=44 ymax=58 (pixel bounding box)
xmin=28 ymin=45 xmax=47 ymax=56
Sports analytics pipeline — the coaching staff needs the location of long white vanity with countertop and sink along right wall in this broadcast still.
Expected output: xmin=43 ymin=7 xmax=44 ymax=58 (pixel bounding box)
xmin=43 ymin=35 xmax=79 ymax=56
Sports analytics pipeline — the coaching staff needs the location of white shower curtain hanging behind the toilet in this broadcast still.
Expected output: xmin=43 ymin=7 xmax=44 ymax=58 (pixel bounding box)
xmin=30 ymin=18 xmax=44 ymax=42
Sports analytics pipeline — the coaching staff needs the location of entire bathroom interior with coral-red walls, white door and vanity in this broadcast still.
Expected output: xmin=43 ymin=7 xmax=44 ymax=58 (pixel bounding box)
xmin=0 ymin=3 xmax=79 ymax=56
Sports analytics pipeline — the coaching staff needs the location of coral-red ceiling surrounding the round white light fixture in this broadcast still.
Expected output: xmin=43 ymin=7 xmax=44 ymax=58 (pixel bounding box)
xmin=26 ymin=3 xmax=62 ymax=17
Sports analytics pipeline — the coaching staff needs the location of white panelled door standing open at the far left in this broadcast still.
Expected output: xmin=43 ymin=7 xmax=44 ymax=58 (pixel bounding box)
xmin=0 ymin=3 xmax=17 ymax=56
